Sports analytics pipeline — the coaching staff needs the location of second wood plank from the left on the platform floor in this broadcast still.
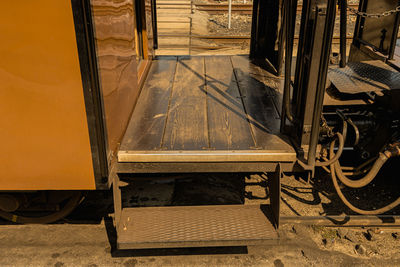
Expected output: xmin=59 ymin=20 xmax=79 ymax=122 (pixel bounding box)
xmin=163 ymin=57 xmax=209 ymax=150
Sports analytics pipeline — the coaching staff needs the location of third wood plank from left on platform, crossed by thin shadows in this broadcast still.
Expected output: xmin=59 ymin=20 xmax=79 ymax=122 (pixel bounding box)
xmin=205 ymin=56 xmax=255 ymax=149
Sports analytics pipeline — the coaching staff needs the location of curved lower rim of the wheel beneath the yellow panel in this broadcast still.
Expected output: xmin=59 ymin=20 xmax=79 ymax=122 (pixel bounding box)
xmin=0 ymin=192 xmax=82 ymax=224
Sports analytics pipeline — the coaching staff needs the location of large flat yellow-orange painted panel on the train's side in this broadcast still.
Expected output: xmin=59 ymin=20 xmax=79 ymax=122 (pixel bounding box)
xmin=0 ymin=0 xmax=95 ymax=190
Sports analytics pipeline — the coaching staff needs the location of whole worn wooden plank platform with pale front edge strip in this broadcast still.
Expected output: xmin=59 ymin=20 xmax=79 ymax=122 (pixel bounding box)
xmin=118 ymin=56 xmax=296 ymax=172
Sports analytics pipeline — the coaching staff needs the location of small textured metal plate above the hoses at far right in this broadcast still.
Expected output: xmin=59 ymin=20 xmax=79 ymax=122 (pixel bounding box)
xmin=328 ymin=60 xmax=400 ymax=94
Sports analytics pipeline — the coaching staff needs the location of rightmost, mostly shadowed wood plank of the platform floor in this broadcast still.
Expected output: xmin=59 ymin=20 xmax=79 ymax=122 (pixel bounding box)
xmin=231 ymin=56 xmax=293 ymax=152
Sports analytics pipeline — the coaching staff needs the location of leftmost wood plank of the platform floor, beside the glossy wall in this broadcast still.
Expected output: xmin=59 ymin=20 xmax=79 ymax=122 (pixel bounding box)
xmin=120 ymin=57 xmax=177 ymax=151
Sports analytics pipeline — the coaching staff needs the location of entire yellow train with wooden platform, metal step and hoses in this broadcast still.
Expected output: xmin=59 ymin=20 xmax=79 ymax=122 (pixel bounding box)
xmin=0 ymin=0 xmax=400 ymax=249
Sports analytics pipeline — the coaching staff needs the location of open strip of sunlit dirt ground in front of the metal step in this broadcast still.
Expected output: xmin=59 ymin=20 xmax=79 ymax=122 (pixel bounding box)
xmin=0 ymin=222 xmax=400 ymax=267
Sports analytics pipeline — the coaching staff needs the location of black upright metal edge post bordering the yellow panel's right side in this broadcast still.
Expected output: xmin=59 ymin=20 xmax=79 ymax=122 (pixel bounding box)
xmin=71 ymin=0 xmax=108 ymax=189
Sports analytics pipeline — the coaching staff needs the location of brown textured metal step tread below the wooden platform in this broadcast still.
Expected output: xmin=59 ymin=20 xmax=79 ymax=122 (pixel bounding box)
xmin=117 ymin=205 xmax=279 ymax=249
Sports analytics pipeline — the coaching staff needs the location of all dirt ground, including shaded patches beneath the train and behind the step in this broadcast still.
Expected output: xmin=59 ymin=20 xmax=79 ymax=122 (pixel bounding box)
xmin=0 ymin=166 xmax=400 ymax=267
